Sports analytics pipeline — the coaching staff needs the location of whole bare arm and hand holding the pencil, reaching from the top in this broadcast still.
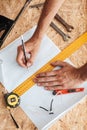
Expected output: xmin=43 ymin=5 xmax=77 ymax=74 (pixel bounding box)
xmin=16 ymin=0 xmax=64 ymax=67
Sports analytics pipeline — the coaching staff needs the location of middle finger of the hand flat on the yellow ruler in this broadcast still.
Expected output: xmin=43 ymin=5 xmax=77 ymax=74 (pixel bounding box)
xmin=34 ymin=76 xmax=58 ymax=83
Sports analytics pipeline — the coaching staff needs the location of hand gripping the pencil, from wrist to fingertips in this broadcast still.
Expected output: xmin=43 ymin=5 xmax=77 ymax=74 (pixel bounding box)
xmin=16 ymin=37 xmax=41 ymax=68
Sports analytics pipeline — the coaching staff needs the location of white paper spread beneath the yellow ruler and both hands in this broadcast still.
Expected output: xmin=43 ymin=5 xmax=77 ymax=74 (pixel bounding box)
xmin=0 ymin=27 xmax=87 ymax=130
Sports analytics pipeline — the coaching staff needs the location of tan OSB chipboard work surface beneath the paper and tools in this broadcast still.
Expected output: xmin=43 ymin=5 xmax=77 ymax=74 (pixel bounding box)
xmin=0 ymin=0 xmax=87 ymax=130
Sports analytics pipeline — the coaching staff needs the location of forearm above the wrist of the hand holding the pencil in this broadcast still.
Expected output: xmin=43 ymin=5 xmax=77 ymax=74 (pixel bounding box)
xmin=34 ymin=0 xmax=64 ymax=39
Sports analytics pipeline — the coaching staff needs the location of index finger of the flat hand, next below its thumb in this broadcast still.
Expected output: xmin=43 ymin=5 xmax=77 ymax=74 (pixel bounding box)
xmin=36 ymin=70 xmax=58 ymax=77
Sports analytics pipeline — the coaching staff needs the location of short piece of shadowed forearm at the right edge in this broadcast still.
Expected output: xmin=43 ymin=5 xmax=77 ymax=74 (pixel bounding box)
xmin=79 ymin=63 xmax=87 ymax=81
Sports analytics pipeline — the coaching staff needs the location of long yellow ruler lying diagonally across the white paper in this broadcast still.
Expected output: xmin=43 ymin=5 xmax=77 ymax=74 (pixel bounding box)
xmin=13 ymin=32 xmax=87 ymax=96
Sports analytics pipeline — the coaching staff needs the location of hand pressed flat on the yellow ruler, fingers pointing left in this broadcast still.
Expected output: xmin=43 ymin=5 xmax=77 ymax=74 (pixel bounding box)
xmin=34 ymin=61 xmax=83 ymax=90
